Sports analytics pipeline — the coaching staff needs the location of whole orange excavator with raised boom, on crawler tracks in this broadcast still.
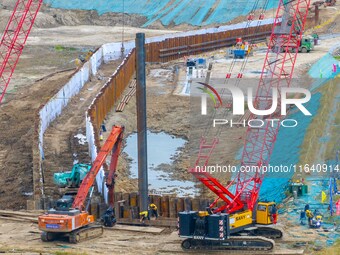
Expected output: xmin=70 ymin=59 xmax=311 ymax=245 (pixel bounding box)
xmin=38 ymin=126 xmax=124 ymax=243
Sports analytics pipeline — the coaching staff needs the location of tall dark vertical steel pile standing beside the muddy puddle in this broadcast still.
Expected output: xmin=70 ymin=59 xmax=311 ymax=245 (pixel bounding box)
xmin=136 ymin=33 xmax=148 ymax=211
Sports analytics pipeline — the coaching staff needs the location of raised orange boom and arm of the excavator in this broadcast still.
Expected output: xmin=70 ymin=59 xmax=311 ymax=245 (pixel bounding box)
xmin=72 ymin=126 xmax=124 ymax=210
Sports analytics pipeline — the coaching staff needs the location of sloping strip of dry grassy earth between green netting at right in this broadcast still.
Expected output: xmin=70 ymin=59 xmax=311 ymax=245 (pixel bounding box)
xmin=298 ymin=80 xmax=337 ymax=165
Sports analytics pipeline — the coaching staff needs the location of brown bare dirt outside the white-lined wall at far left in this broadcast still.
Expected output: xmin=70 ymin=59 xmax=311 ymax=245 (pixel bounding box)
xmin=0 ymin=71 xmax=72 ymax=209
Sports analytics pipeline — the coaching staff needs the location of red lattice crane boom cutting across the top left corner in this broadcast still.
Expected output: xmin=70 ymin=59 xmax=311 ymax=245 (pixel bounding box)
xmin=0 ymin=0 xmax=43 ymax=103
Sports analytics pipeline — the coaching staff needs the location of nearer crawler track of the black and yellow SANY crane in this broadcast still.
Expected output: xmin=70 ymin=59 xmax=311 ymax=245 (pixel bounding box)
xmin=182 ymin=236 xmax=275 ymax=251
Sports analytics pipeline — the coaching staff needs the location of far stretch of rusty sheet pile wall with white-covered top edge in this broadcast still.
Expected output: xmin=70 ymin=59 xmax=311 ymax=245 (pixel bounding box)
xmin=103 ymin=18 xmax=274 ymax=62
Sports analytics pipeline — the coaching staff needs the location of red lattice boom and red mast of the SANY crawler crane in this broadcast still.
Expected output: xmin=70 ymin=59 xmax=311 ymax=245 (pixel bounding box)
xmin=190 ymin=0 xmax=310 ymax=213
